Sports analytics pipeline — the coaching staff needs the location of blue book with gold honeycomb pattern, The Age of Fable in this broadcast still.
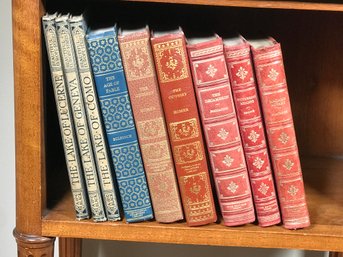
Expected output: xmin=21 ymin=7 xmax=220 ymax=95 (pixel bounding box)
xmin=87 ymin=28 xmax=153 ymax=222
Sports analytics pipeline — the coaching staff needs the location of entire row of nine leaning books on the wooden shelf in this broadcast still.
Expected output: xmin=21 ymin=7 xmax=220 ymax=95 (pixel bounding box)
xmin=42 ymin=14 xmax=310 ymax=229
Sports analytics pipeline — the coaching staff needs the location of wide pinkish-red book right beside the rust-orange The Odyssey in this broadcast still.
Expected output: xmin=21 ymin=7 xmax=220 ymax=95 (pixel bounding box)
xmin=187 ymin=36 xmax=255 ymax=226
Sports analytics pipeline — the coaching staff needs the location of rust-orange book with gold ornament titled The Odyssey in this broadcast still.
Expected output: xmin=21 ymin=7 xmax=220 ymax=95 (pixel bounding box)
xmin=151 ymin=29 xmax=217 ymax=226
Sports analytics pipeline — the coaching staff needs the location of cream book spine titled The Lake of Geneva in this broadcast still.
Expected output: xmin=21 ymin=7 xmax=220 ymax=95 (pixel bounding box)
xmin=56 ymin=15 xmax=106 ymax=221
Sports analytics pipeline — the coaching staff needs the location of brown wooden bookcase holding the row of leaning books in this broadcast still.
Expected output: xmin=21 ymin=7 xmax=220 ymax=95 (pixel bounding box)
xmin=13 ymin=0 xmax=343 ymax=257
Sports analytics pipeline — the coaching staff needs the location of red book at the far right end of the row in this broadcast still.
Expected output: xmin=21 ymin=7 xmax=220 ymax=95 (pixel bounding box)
xmin=249 ymin=38 xmax=310 ymax=229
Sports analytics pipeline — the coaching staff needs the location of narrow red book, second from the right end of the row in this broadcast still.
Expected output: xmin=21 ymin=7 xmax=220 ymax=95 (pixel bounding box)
xmin=224 ymin=37 xmax=281 ymax=227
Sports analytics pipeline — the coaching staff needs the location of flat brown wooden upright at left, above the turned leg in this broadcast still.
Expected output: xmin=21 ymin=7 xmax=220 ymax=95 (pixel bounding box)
xmin=12 ymin=0 xmax=45 ymax=235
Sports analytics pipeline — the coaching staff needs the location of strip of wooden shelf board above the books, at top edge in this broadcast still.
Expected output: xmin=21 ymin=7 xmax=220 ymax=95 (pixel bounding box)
xmin=125 ymin=0 xmax=343 ymax=11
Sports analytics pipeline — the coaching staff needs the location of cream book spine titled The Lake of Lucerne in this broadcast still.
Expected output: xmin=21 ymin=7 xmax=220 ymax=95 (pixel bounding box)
xmin=42 ymin=15 xmax=89 ymax=220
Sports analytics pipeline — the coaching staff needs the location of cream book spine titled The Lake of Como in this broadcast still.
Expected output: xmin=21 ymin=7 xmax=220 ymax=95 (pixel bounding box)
xmin=69 ymin=16 xmax=120 ymax=221
